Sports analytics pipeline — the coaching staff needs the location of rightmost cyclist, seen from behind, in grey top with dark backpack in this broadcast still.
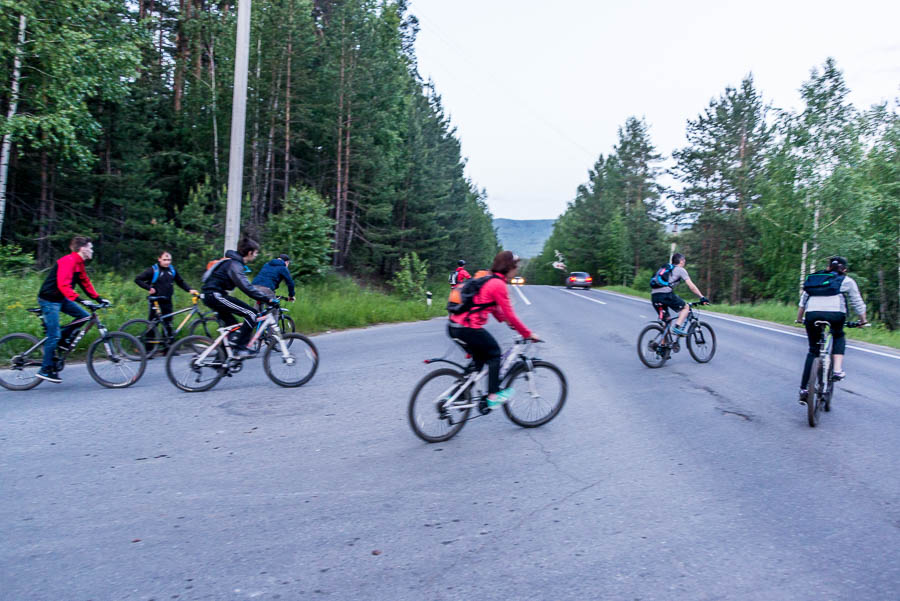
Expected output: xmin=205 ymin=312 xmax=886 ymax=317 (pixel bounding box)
xmin=797 ymin=256 xmax=867 ymax=404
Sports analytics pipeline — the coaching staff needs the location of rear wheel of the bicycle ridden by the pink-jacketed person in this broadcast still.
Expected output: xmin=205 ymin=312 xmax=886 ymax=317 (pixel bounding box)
xmin=407 ymin=368 xmax=472 ymax=442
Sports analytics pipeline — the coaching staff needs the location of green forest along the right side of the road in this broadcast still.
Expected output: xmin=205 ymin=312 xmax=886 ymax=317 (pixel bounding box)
xmin=526 ymin=59 xmax=900 ymax=329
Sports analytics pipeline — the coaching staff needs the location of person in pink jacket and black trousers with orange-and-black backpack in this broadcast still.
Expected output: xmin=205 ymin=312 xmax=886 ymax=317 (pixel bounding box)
xmin=448 ymin=250 xmax=540 ymax=407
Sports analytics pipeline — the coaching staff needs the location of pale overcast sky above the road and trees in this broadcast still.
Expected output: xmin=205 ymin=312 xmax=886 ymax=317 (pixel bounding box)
xmin=410 ymin=0 xmax=900 ymax=219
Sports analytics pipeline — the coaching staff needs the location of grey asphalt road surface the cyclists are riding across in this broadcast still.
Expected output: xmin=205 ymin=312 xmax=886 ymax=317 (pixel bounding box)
xmin=0 ymin=286 xmax=900 ymax=601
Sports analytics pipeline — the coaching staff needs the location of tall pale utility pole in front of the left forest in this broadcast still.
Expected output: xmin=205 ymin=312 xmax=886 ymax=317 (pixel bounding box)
xmin=225 ymin=0 xmax=251 ymax=251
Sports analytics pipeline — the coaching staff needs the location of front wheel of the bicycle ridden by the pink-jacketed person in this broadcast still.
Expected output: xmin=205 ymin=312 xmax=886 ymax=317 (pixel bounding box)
xmin=503 ymin=361 xmax=569 ymax=428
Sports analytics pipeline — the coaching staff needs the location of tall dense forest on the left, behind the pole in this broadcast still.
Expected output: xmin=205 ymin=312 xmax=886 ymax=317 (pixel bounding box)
xmin=0 ymin=0 xmax=498 ymax=280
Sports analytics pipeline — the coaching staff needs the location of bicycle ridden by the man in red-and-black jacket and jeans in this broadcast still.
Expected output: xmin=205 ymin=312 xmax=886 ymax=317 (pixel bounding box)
xmin=0 ymin=301 xmax=147 ymax=390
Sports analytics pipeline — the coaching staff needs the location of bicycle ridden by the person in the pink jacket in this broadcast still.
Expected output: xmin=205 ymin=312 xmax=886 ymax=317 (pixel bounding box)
xmin=407 ymin=337 xmax=568 ymax=442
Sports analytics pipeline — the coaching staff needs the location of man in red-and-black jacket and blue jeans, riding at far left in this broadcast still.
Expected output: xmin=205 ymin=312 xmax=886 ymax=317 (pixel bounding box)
xmin=36 ymin=236 xmax=109 ymax=384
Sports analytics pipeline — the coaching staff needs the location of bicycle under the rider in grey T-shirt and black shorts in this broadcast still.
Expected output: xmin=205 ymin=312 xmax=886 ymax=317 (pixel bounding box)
xmin=637 ymin=303 xmax=716 ymax=368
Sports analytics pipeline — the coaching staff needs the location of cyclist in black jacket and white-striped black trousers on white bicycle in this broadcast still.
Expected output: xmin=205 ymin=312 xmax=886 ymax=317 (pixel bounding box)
xmin=203 ymin=238 xmax=269 ymax=357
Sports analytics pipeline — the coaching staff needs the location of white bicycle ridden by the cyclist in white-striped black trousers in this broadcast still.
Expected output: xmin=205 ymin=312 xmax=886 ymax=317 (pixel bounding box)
xmin=166 ymin=302 xmax=319 ymax=392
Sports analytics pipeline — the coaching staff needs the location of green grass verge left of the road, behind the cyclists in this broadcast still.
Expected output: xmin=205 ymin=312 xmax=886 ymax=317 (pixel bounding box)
xmin=0 ymin=273 xmax=446 ymax=354
